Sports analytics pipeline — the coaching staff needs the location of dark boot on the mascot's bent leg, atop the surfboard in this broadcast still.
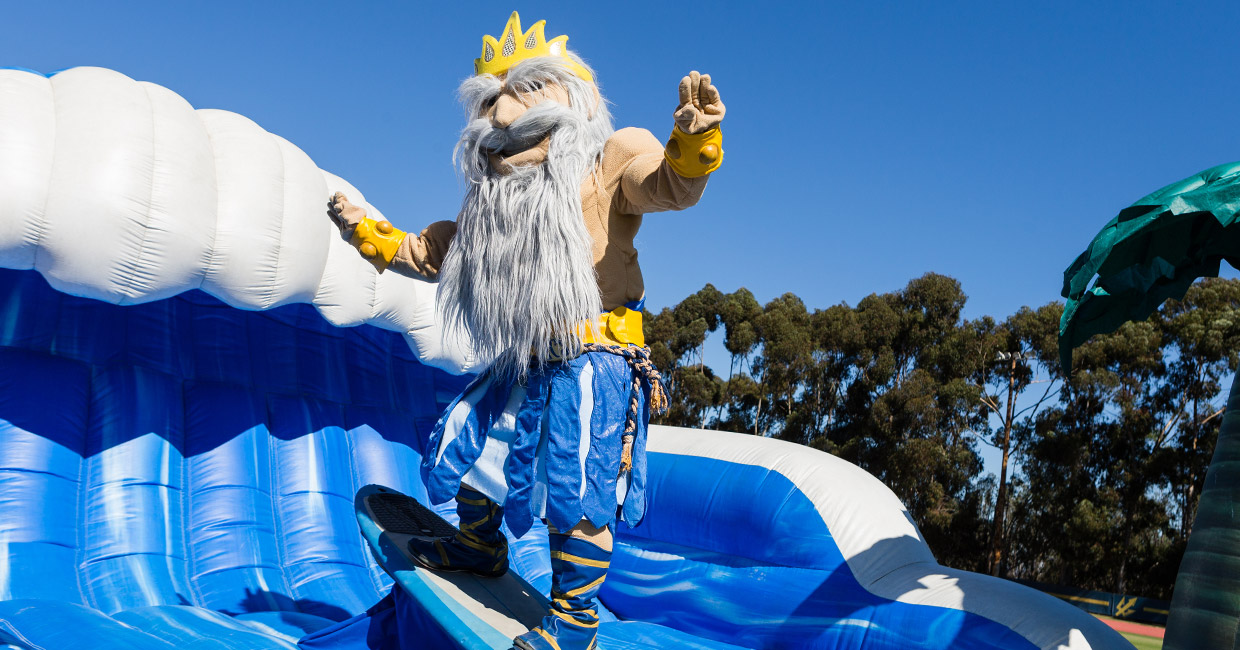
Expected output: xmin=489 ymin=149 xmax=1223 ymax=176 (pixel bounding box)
xmin=409 ymin=484 xmax=508 ymax=578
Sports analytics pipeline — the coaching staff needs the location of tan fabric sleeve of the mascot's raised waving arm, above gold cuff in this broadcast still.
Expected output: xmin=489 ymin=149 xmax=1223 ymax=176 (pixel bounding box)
xmin=603 ymin=128 xmax=708 ymax=215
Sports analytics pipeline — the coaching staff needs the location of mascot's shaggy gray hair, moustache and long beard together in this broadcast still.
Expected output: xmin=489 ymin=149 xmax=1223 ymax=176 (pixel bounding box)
xmin=438 ymin=57 xmax=613 ymax=380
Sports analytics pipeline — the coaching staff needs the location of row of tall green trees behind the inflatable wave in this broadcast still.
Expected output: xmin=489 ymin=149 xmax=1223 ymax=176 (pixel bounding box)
xmin=645 ymin=273 xmax=1240 ymax=597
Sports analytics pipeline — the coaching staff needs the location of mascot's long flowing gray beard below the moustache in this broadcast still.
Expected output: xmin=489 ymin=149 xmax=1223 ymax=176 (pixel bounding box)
xmin=438 ymin=120 xmax=610 ymax=380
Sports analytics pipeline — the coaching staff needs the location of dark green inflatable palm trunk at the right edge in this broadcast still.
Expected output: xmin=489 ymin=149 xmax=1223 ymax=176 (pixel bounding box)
xmin=1163 ymin=380 xmax=1240 ymax=650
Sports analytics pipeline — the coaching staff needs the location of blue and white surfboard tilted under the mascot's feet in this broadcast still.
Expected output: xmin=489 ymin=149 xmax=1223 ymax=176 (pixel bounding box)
xmin=353 ymin=485 xmax=551 ymax=650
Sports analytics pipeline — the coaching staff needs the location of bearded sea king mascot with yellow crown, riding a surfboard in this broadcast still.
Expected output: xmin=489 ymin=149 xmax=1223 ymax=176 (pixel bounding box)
xmin=330 ymin=12 xmax=724 ymax=650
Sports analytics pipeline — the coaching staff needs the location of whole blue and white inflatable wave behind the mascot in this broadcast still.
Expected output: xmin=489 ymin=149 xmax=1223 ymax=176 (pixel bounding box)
xmin=0 ymin=68 xmax=1131 ymax=650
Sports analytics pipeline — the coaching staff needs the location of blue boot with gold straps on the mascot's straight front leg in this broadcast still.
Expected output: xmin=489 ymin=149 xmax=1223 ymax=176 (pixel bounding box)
xmin=512 ymin=522 xmax=611 ymax=650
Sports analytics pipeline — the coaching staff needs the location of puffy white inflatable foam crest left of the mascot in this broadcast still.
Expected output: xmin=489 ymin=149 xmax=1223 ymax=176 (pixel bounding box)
xmin=0 ymin=67 xmax=476 ymax=373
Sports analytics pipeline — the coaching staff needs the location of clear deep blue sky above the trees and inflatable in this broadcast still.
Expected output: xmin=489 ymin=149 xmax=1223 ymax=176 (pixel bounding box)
xmin=0 ymin=0 xmax=1240 ymax=471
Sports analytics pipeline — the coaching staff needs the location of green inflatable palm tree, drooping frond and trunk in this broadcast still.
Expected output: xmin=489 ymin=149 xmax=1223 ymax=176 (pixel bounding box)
xmin=1059 ymin=163 xmax=1240 ymax=650
